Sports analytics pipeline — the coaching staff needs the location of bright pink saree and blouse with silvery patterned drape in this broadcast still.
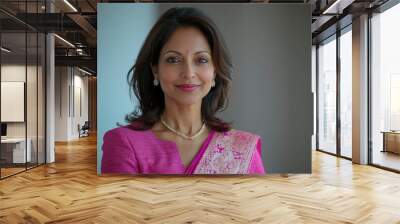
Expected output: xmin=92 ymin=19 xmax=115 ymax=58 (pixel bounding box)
xmin=101 ymin=127 xmax=265 ymax=175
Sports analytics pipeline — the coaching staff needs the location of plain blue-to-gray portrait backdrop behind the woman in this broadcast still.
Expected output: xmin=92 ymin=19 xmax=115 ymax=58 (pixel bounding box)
xmin=97 ymin=3 xmax=313 ymax=173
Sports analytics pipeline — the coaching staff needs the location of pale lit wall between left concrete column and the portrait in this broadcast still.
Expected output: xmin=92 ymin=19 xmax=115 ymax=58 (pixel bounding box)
xmin=55 ymin=67 xmax=88 ymax=141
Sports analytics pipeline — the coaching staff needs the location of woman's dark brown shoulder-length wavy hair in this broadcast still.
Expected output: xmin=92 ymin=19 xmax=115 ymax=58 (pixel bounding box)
xmin=125 ymin=7 xmax=232 ymax=132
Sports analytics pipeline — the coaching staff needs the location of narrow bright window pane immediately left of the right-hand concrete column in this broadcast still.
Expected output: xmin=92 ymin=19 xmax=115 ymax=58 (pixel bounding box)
xmin=340 ymin=30 xmax=353 ymax=158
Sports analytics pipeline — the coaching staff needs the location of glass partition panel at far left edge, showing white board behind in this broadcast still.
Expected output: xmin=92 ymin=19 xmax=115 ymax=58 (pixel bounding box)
xmin=0 ymin=32 xmax=29 ymax=178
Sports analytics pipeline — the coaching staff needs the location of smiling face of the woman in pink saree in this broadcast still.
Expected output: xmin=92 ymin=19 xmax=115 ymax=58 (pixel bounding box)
xmin=153 ymin=27 xmax=215 ymax=105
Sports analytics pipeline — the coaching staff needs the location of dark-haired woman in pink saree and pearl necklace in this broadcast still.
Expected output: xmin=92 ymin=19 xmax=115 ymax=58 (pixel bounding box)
xmin=102 ymin=8 xmax=265 ymax=174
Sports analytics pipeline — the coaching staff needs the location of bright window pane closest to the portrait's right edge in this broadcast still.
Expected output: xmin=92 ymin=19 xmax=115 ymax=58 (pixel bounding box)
xmin=318 ymin=37 xmax=336 ymax=154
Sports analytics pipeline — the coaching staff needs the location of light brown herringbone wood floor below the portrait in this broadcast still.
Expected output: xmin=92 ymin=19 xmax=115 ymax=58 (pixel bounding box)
xmin=0 ymin=134 xmax=400 ymax=224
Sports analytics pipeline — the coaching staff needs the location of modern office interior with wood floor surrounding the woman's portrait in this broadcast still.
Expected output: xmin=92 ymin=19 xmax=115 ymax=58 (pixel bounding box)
xmin=0 ymin=0 xmax=400 ymax=223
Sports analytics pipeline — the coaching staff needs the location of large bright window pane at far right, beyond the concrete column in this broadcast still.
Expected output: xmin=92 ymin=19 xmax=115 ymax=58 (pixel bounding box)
xmin=371 ymin=4 xmax=400 ymax=170
